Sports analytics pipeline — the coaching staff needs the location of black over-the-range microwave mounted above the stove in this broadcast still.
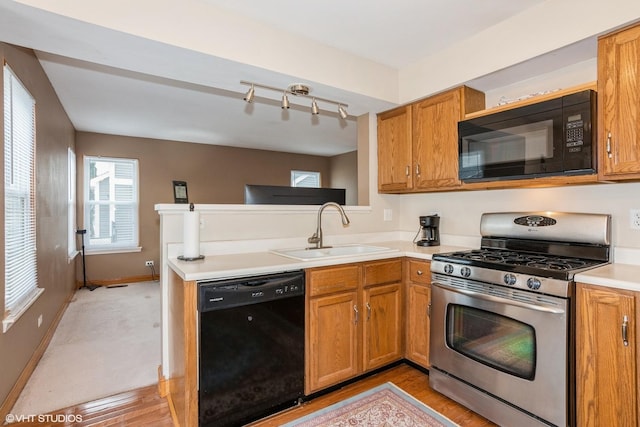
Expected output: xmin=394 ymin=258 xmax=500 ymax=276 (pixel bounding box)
xmin=458 ymin=90 xmax=596 ymax=182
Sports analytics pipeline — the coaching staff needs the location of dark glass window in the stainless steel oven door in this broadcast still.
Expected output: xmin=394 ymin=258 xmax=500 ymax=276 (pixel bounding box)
xmin=446 ymin=304 xmax=536 ymax=380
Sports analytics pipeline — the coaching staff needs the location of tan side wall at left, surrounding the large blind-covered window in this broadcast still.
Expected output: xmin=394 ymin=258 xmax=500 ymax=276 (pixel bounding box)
xmin=0 ymin=43 xmax=76 ymax=410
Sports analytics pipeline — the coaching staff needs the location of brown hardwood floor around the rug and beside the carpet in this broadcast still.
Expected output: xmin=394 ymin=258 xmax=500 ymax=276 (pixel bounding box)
xmin=6 ymin=364 xmax=495 ymax=427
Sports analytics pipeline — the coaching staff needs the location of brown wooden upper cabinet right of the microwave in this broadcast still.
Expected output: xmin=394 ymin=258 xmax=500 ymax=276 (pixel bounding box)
xmin=598 ymin=25 xmax=640 ymax=181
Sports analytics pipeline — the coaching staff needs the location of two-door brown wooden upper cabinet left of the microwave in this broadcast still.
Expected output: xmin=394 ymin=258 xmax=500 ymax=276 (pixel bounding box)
xmin=378 ymin=86 xmax=485 ymax=193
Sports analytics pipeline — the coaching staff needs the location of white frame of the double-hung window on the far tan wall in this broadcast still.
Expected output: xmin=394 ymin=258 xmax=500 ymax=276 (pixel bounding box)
xmin=83 ymin=156 xmax=142 ymax=255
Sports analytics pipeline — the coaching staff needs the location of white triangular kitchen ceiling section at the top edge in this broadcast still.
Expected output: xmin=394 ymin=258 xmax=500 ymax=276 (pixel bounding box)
xmin=204 ymin=0 xmax=544 ymax=68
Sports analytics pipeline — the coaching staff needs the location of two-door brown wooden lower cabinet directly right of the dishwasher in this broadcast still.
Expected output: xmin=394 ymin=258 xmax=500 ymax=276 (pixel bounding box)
xmin=305 ymin=258 xmax=404 ymax=394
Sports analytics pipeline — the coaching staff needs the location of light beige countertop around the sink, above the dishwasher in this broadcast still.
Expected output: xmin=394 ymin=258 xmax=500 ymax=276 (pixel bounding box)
xmin=168 ymin=241 xmax=468 ymax=280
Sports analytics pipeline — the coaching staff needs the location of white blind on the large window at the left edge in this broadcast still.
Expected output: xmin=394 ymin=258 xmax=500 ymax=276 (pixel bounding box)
xmin=3 ymin=64 xmax=43 ymax=332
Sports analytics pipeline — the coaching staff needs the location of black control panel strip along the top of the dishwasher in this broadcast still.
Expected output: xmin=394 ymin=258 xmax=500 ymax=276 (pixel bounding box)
xmin=198 ymin=270 xmax=305 ymax=312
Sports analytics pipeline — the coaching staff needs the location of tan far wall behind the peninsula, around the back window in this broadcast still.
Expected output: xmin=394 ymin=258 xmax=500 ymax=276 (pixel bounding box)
xmin=76 ymin=132 xmax=355 ymax=283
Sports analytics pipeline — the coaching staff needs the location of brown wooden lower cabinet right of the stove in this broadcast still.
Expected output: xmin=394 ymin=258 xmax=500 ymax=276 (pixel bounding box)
xmin=576 ymin=283 xmax=640 ymax=427
